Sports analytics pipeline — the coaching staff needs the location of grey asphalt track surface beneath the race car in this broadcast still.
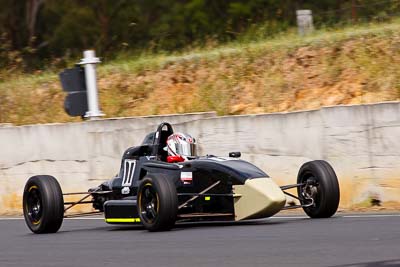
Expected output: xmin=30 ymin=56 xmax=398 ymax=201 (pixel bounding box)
xmin=0 ymin=214 xmax=400 ymax=267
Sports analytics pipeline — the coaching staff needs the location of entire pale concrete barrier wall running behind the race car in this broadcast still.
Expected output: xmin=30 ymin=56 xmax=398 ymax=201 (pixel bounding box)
xmin=0 ymin=102 xmax=400 ymax=214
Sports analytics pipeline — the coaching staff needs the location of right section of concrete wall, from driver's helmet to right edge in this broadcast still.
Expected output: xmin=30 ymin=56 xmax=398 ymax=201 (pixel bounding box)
xmin=183 ymin=102 xmax=400 ymax=208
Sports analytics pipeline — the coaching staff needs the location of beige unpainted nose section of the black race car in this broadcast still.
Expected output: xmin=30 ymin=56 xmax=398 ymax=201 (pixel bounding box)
xmin=233 ymin=178 xmax=286 ymax=221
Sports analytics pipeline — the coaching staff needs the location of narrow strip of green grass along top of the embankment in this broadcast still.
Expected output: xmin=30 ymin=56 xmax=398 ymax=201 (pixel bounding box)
xmin=99 ymin=19 xmax=400 ymax=72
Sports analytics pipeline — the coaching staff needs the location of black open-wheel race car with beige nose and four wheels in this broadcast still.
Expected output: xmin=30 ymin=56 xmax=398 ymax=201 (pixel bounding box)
xmin=23 ymin=123 xmax=340 ymax=234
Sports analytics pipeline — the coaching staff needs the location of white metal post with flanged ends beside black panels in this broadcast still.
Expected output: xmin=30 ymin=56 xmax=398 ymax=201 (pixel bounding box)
xmin=79 ymin=50 xmax=104 ymax=120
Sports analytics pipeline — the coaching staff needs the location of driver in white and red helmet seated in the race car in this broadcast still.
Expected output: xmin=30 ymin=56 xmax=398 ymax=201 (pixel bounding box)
xmin=166 ymin=133 xmax=197 ymax=163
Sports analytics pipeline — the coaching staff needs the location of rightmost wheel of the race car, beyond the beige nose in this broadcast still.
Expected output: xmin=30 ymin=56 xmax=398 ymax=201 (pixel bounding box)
xmin=297 ymin=160 xmax=340 ymax=218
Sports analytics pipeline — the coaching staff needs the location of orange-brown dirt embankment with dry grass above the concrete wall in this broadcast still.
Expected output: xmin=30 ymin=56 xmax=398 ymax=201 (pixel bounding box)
xmin=0 ymin=27 xmax=400 ymax=124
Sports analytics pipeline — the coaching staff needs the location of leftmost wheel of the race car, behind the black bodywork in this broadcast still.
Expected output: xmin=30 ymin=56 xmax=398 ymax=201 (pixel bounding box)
xmin=22 ymin=175 xmax=64 ymax=234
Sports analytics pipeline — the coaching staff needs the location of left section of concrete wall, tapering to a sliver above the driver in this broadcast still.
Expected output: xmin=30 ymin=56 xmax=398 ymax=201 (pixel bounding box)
xmin=0 ymin=112 xmax=216 ymax=215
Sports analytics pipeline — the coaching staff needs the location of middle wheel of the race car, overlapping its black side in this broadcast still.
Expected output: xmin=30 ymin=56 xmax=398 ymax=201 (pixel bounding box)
xmin=137 ymin=174 xmax=178 ymax=231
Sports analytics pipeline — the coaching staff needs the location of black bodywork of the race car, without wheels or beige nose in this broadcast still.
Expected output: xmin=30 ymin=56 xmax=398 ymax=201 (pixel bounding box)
xmin=89 ymin=123 xmax=268 ymax=223
